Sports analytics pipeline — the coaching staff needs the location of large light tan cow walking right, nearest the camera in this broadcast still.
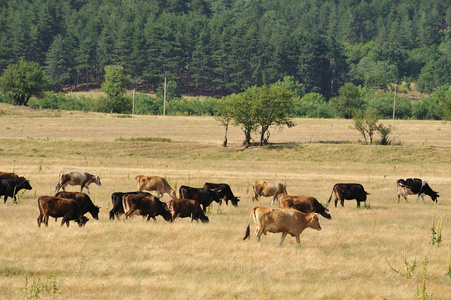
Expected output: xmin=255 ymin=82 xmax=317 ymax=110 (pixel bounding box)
xmin=243 ymin=206 xmax=321 ymax=247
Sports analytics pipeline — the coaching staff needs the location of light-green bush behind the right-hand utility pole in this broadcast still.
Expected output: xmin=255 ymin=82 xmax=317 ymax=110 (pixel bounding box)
xmin=366 ymin=94 xmax=412 ymax=119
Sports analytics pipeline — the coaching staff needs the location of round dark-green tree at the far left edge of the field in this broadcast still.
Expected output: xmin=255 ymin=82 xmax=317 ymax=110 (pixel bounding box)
xmin=0 ymin=60 xmax=48 ymax=105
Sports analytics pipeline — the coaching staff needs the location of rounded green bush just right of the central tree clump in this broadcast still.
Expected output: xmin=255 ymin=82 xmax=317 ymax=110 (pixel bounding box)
xmin=293 ymin=93 xmax=335 ymax=118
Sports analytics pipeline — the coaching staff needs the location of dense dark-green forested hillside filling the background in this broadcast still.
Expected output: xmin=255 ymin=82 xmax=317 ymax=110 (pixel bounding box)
xmin=0 ymin=0 xmax=451 ymax=99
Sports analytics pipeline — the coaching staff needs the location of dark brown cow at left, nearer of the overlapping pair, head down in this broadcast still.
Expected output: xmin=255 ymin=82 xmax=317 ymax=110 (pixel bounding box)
xmin=37 ymin=196 xmax=89 ymax=227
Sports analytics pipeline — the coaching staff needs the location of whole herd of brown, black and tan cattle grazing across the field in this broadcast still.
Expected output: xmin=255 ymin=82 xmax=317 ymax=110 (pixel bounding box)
xmin=0 ymin=171 xmax=439 ymax=245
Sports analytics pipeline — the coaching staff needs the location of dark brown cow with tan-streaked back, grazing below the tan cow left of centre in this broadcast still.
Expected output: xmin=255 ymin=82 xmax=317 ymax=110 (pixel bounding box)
xmin=122 ymin=194 xmax=172 ymax=222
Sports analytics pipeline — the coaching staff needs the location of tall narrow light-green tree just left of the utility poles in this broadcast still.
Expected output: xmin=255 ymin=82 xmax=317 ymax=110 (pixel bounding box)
xmin=101 ymin=65 xmax=130 ymax=113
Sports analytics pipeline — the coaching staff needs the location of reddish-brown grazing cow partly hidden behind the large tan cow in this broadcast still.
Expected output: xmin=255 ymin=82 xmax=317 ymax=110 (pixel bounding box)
xmin=278 ymin=194 xmax=332 ymax=219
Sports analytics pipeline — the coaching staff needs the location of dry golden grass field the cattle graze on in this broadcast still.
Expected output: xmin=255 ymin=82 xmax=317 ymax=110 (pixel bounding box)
xmin=0 ymin=104 xmax=451 ymax=299
